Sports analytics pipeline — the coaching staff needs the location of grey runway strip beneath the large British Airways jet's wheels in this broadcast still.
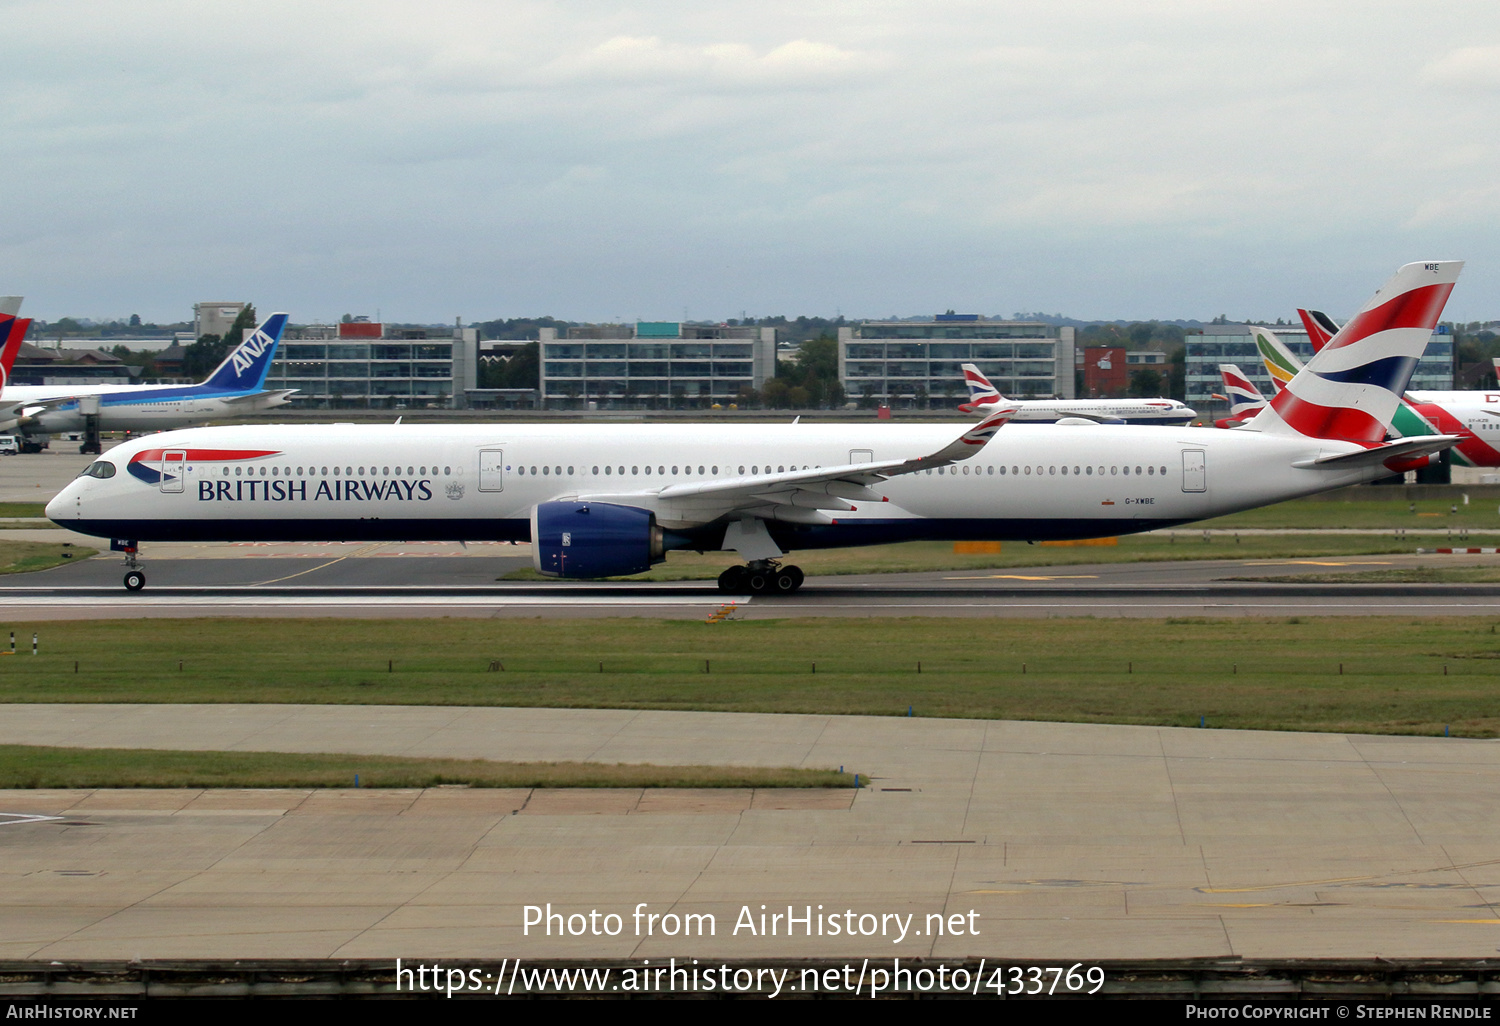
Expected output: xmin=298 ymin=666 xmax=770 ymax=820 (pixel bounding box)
xmin=0 ymin=546 xmax=1500 ymax=620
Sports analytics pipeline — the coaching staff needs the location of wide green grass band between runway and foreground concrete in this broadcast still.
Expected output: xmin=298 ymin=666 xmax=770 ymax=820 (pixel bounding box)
xmin=0 ymin=617 xmax=1500 ymax=737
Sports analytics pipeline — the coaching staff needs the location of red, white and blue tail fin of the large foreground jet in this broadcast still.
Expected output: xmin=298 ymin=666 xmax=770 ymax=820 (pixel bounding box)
xmin=1256 ymin=260 xmax=1464 ymax=447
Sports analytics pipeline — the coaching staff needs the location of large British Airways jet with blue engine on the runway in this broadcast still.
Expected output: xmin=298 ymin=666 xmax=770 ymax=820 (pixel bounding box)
xmin=47 ymin=261 xmax=1463 ymax=591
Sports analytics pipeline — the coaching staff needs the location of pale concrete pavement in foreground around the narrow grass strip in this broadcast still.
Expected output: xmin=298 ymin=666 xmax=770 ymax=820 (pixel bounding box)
xmin=0 ymin=705 xmax=1500 ymax=965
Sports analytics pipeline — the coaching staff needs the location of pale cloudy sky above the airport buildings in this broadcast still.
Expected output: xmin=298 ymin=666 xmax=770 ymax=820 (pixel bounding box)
xmin=0 ymin=0 xmax=1500 ymax=321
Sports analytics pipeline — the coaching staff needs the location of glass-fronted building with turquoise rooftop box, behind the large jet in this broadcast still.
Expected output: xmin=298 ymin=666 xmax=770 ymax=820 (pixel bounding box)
xmin=540 ymin=321 xmax=776 ymax=410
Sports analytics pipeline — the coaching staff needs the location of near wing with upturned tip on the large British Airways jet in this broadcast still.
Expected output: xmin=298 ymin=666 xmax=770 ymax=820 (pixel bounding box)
xmin=579 ymin=405 xmax=1017 ymax=524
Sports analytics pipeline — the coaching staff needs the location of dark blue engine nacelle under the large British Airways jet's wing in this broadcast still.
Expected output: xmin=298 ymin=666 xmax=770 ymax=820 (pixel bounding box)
xmin=531 ymin=500 xmax=666 ymax=578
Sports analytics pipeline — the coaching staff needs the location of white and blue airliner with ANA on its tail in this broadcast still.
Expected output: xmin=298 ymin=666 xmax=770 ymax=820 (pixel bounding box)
xmin=0 ymin=314 xmax=296 ymax=438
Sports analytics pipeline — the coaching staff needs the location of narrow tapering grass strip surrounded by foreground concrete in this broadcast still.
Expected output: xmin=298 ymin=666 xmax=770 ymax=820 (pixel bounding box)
xmin=0 ymin=744 xmax=854 ymax=789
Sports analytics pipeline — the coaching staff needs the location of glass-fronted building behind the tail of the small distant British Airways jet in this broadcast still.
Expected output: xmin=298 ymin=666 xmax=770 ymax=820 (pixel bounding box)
xmin=839 ymin=314 xmax=1076 ymax=410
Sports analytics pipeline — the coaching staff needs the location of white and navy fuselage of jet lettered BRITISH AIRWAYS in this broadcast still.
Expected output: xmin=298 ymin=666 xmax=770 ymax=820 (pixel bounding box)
xmin=47 ymin=423 xmax=1389 ymax=549
